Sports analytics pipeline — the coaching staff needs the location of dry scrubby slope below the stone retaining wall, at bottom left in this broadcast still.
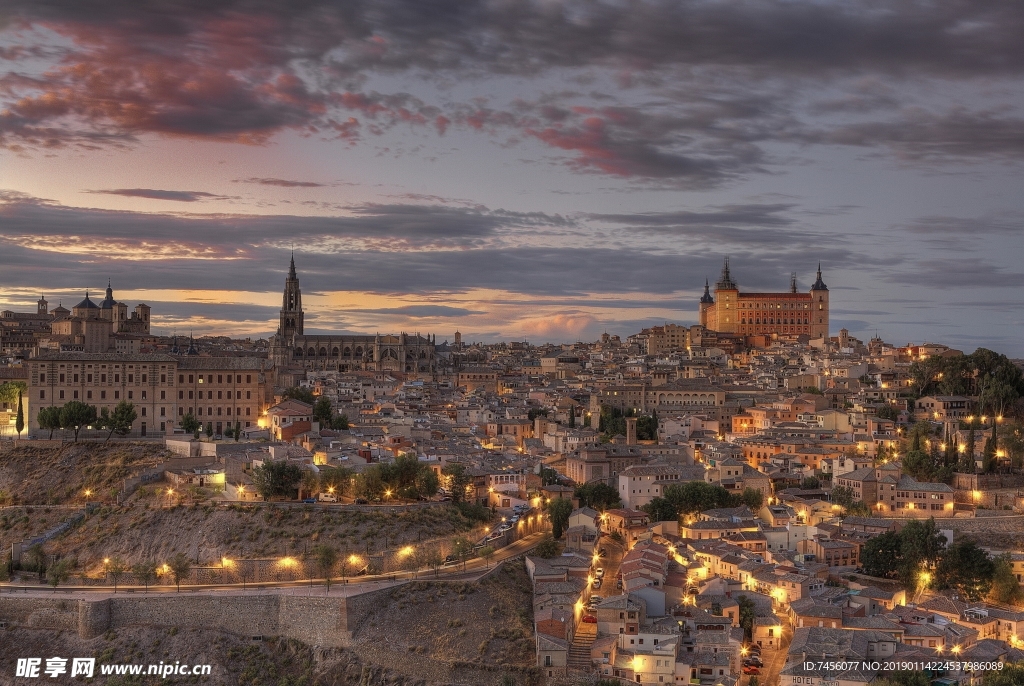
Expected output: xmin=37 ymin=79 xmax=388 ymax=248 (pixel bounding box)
xmin=0 ymin=562 xmax=542 ymax=686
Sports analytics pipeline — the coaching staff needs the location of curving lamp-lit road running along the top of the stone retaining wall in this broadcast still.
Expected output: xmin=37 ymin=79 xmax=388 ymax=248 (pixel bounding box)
xmin=0 ymin=531 xmax=545 ymax=595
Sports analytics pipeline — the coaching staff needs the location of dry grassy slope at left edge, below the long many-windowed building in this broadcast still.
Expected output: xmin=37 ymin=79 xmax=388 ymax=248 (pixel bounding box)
xmin=0 ymin=441 xmax=171 ymax=505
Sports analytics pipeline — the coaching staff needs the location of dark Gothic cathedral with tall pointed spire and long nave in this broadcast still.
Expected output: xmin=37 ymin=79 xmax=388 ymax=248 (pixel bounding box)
xmin=270 ymin=256 xmax=435 ymax=385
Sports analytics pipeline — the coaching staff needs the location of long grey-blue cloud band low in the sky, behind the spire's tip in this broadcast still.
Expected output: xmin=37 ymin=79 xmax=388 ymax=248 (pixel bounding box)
xmin=0 ymin=196 xmax=880 ymax=298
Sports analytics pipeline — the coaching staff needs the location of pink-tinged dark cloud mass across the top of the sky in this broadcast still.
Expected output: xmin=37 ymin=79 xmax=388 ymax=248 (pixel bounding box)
xmin=0 ymin=0 xmax=1024 ymax=182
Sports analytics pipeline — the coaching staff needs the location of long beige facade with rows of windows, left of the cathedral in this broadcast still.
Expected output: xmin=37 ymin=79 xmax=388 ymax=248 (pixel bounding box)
xmin=29 ymin=352 xmax=273 ymax=436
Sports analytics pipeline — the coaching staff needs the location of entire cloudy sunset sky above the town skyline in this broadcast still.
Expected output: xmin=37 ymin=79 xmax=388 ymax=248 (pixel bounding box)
xmin=0 ymin=0 xmax=1024 ymax=357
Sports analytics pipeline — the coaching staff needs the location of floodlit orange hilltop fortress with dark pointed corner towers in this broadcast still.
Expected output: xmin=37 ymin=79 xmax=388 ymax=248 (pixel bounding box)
xmin=699 ymin=258 xmax=828 ymax=338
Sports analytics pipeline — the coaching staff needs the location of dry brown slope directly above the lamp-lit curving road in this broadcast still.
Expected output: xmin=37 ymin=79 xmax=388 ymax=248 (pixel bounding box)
xmin=47 ymin=505 xmax=493 ymax=570
